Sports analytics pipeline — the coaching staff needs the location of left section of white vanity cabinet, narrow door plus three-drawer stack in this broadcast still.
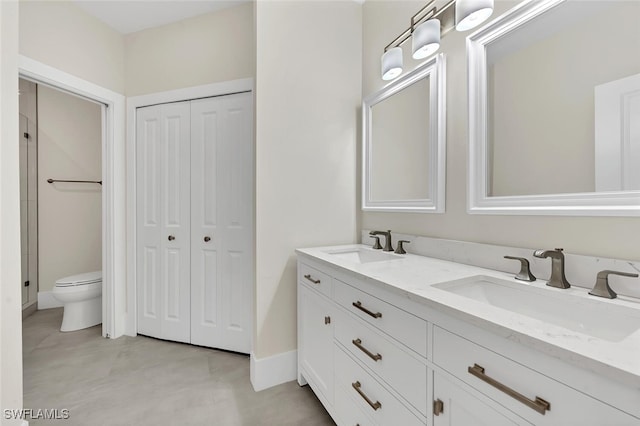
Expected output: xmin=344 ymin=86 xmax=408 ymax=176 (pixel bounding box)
xmin=298 ymin=260 xmax=430 ymax=426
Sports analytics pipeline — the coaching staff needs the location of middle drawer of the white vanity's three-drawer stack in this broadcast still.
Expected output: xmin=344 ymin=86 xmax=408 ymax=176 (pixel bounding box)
xmin=334 ymin=312 xmax=427 ymax=416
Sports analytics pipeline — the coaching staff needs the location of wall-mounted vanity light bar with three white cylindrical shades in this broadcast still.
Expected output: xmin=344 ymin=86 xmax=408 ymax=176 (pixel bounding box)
xmin=381 ymin=0 xmax=493 ymax=80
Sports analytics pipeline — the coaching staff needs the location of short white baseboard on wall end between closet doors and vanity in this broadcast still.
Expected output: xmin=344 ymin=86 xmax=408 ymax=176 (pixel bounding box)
xmin=249 ymin=351 xmax=298 ymax=392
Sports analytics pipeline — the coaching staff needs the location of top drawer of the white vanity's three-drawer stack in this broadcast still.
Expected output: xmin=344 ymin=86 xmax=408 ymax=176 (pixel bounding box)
xmin=334 ymin=280 xmax=427 ymax=358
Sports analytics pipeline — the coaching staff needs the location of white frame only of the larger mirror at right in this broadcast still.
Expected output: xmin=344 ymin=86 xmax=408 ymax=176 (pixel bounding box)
xmin=467 ymin=0 xmax=640 ymax=216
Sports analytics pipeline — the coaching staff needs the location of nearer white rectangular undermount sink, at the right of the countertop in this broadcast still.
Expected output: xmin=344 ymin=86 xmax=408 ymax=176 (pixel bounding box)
xmin=433 ymin=275 xmax=640 ymax=342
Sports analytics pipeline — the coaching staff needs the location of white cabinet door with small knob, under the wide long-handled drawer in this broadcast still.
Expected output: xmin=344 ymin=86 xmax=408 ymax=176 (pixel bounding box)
xmin=433 ymin=373 xmax=530 ymax=426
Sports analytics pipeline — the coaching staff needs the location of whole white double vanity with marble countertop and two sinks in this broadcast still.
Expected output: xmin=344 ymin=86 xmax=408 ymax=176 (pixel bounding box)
xmin=297 ymin=241 xmax=640 ymax=426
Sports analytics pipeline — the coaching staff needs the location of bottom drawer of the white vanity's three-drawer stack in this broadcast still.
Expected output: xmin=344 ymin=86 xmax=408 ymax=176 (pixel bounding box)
xmin=334 ymin=346 xmax=426 ymax=426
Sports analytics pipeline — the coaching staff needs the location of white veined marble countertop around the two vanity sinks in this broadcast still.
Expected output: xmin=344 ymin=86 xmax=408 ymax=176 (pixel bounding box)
xmin=296 ymin=244 xmax=640 ymax=387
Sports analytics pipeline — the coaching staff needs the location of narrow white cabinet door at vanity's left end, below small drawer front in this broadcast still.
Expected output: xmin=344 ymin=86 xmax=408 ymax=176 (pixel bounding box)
xmin=298 ymin=285 xmax=334 ymax=404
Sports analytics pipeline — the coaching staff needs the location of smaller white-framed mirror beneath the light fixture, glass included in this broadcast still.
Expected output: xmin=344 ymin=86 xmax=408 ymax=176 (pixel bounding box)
xmin=362 ymin=54 xmax=445 ymax=213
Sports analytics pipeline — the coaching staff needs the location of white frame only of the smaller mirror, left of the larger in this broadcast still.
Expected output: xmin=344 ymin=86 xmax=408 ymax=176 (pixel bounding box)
xmin=362 ymin=53 xmax=446 ymax=213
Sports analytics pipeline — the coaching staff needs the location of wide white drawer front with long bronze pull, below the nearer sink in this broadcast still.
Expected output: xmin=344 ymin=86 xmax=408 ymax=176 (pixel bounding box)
xmin=433 ymin=327 xmax=640 ymax=426
